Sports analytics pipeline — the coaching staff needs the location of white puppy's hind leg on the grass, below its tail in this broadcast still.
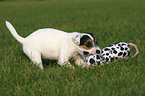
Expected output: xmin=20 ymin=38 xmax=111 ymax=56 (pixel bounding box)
xmin=24 ymin=51 xmax=43 ymax=70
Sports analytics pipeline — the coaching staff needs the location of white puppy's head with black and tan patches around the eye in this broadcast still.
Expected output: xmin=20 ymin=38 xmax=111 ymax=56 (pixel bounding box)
xmin=72 ymin=33 xmax=100 ymax=55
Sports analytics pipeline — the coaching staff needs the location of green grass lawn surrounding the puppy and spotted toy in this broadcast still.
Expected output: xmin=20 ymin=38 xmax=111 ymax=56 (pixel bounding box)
xmin=0 ymin=0 xmax=145 ymax=96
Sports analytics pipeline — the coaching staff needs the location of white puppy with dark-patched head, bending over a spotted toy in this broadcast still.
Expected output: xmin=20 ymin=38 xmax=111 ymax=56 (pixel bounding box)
xmin=6 ymin=21 xmax=99 ymax=69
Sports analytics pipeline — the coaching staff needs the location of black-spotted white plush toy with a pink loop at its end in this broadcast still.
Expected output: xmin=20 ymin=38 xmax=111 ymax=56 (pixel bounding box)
xmin=83 ymin=42 xmax=139 ymax=67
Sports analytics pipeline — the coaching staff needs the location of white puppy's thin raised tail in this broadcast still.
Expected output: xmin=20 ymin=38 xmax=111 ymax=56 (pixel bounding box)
xmin=6 ymin=21 xmax=25 ymax=44
